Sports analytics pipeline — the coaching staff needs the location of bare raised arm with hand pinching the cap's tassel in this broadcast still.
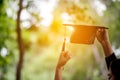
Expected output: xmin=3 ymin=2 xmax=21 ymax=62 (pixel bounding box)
xmin=55 ymin=51 xmax=70 ymax=80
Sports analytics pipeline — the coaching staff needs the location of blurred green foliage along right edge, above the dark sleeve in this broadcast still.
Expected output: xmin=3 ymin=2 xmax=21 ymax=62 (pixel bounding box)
xmin=103 ymin=0 xmax=120 ymax=48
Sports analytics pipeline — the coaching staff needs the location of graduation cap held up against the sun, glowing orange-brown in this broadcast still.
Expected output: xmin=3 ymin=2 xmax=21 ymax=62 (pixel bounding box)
xmin=63 ymin=24 xmax=108 ymax=44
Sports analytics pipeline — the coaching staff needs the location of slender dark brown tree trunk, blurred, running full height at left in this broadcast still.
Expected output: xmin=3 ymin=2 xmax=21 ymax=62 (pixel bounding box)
xmin=16 ymin=0 xmax=24 ymax=80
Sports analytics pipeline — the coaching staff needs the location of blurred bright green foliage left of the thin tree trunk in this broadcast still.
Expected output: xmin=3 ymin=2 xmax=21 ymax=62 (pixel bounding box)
xmin=0 ymin=0 xmax=17 ymax=80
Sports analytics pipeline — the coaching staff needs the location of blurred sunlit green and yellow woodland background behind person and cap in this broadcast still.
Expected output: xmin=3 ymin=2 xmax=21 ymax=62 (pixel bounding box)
xmin=0 ymin=0 xmax=120 ymax=80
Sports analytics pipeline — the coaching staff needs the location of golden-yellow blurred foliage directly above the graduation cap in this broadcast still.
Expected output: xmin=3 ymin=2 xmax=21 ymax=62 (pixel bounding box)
xmin=55 ymin=0 xmax=99 ymax=24
